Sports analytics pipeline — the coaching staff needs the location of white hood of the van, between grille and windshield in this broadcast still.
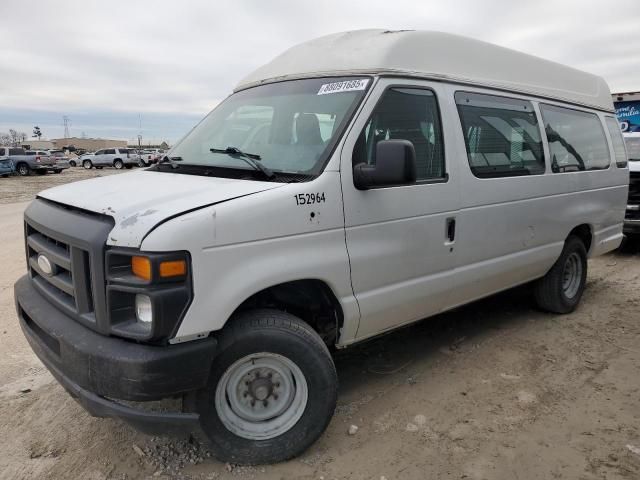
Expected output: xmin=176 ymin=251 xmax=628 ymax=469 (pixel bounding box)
xmin=38 ymin=170 xmax=284 ymax=248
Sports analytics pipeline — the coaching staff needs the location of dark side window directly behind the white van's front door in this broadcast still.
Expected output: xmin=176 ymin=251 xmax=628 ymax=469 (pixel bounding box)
xmin=455 ymin=92 xmax=545 ymax=178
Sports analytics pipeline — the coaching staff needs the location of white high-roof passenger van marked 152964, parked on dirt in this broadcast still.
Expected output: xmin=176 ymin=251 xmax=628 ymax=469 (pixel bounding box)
xmin=15 ymin=30 xmax=629 ymax=463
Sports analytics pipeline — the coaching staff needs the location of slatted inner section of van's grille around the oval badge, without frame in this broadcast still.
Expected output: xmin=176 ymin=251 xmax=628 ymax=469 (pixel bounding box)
xmin=26 ymin=224 xmax=95 ymax=322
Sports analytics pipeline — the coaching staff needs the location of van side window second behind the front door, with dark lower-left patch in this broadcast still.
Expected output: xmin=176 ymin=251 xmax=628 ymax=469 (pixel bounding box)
xmin=540 ymin=104 xmax=611 ymax=173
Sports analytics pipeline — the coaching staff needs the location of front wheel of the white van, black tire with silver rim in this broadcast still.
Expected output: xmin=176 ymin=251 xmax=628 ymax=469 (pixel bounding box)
xmin=196 ymin=309 xmax=338 ymax=465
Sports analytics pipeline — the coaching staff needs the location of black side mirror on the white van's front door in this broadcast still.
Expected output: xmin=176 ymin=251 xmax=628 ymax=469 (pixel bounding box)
xmin=353 ymin=140 xmax=416 ymax=190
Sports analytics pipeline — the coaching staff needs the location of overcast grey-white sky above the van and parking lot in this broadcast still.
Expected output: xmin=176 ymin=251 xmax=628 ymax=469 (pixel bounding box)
xmin=0 ymin=0 xmax=640 ymax=143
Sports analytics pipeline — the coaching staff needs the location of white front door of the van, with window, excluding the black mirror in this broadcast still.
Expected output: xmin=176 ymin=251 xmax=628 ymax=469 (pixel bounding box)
xmin=341 ymin=79 xmax=459 ymax=338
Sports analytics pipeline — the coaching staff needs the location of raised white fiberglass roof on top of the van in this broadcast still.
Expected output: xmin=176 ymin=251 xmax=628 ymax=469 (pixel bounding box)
xmin=236 ymin=29 xmax=613 ymax=111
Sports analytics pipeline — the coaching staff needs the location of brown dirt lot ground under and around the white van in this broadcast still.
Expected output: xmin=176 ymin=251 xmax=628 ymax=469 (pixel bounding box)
xmin=0 ymin=170 xmax=640 ymax=480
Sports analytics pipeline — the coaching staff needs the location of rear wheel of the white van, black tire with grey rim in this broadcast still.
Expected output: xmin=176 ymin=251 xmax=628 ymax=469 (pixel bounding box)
xmin=534 ymin=235 xmax=587 ymax=313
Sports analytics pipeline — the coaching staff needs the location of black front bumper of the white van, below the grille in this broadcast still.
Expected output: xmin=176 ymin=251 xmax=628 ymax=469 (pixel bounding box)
xmin=14 ymin=275 xmax=217 ymax=433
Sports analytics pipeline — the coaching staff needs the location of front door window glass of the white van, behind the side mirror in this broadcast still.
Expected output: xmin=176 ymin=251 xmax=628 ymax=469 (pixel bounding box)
xmin=352 ymin=88 xmax=445 ymax=181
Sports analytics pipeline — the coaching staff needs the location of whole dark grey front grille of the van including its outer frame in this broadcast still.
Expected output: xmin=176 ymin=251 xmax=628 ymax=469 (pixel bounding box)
xmin=24 ymin=199 xmax=113 ymax=334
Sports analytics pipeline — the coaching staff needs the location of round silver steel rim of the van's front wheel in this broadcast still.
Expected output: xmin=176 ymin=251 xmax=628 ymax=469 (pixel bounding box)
xmin=215 ymin=352 xmax=309 ymax=440
